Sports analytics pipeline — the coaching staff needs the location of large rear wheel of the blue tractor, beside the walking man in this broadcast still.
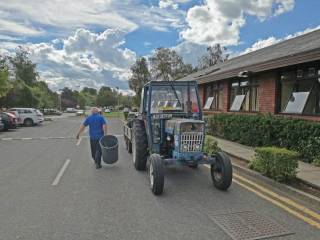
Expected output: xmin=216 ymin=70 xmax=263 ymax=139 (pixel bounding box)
xmin=129 ymin=120 xmax=148 ymax=171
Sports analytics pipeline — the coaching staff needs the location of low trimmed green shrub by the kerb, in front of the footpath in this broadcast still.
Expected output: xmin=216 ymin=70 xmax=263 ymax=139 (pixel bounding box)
xmin=249 ymin=147 xmax=299 ymax=182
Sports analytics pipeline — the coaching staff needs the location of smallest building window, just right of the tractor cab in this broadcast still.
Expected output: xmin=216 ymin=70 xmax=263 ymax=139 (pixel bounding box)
xmin=203 ymin=83 xmax=223 ymax=111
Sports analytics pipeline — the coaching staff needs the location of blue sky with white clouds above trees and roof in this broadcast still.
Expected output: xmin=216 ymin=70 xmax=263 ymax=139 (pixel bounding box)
xmin=0 ymin=0 xmax=320 ymax=93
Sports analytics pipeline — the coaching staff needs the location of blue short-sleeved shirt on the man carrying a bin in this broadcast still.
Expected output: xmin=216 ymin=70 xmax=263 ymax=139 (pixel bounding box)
xmin=83 ymin=113 xmax=107 ymax=140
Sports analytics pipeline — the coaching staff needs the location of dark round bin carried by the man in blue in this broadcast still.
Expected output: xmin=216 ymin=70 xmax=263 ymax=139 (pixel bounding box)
xmin=99 ymin=135 xmax=119 ymax=164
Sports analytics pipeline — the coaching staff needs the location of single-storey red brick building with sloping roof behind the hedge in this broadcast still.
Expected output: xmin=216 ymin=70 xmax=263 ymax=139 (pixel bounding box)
xmin=181 ymin=30 xmax=320 ymax=121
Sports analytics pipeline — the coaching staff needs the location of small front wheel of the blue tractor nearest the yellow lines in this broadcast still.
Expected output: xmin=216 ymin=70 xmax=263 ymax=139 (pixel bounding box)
xmin=211 ymin=152 xmax=232 ymax=191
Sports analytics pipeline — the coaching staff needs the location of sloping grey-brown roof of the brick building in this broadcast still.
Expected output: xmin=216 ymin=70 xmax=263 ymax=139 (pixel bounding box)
xmin=180 ymin=29 xmax=320 ymax=83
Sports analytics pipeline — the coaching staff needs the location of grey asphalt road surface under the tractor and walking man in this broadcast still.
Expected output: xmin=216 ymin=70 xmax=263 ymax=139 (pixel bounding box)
xmin=0 ymin=117 xmax=320 ymax=240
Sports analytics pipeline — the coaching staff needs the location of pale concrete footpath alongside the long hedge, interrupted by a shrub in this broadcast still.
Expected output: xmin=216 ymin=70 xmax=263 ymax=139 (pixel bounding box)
xmin=214 ymin=137 xmax=320 ymax=189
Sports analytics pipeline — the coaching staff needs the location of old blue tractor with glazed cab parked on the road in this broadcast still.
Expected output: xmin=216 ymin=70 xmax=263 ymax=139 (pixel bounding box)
xmin=124 ymin=81 xmax=232 ymax=195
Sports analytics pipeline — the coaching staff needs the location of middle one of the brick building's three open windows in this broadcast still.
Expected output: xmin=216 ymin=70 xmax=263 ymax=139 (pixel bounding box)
xmin=230 ymin=80 xmax=259 ymax=112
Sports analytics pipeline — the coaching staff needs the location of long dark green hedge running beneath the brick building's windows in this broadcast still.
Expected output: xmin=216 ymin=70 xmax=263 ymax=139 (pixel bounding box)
xmin=206 ymin=114 xmax=320 ymax=162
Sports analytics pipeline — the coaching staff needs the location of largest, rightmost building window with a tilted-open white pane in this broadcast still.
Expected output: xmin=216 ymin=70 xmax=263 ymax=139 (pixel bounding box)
xmin=280 ymin=67 xmax=320 ymax=115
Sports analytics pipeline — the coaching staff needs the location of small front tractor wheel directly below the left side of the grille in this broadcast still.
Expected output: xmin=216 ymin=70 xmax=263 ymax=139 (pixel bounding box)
xmin=149 ymin=153 xmax=164 ymax=195
